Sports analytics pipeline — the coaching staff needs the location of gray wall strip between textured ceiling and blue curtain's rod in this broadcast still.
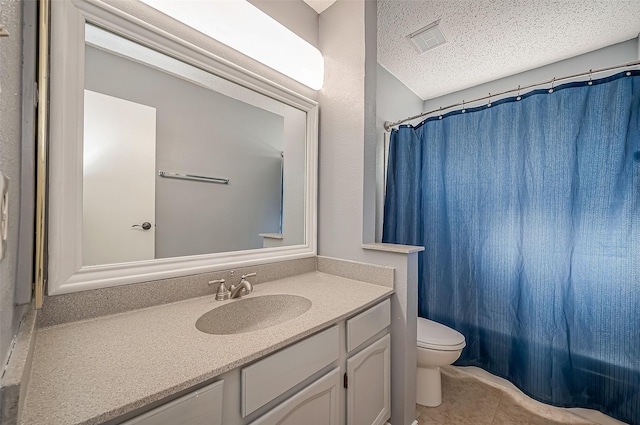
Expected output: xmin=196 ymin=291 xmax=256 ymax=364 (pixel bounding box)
xmin=422 ymin=38 xmax=638 ymax=112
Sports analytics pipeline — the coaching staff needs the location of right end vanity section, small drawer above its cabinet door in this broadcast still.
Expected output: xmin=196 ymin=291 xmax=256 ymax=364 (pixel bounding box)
xmin=345 ymin=299 xmax=391 ymax=425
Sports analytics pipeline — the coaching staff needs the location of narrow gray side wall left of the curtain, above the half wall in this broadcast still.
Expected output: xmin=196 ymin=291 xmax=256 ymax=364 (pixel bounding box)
xmin=376 ymin=64 xmax=423 ymax=242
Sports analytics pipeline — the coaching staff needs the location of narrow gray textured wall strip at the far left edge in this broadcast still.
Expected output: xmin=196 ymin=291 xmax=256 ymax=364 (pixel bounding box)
xmin=0 ymin=0 xmax=23 ymax=365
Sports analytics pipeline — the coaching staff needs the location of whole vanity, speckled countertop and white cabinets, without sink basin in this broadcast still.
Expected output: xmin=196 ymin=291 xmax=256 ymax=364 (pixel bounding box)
xmin=22 ymin=272 xmax=393 ymax=425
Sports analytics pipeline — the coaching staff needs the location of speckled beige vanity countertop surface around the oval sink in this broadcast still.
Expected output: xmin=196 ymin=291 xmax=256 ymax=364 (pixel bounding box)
xmin=21 ymin=272 xmax=393 ymax=425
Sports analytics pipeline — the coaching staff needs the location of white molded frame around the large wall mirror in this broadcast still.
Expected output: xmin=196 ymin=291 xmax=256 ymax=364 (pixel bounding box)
xmin=47 ymin=0 xmax=318 ymax=295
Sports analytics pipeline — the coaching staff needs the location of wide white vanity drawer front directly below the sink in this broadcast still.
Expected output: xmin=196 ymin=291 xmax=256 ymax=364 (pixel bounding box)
xmin=241 ymin=325 xmax=340 ymax=418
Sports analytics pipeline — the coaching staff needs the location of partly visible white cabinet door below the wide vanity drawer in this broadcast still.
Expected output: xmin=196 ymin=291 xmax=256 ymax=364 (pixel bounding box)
xmin=251 ymin=368 xmax=340 ymax=425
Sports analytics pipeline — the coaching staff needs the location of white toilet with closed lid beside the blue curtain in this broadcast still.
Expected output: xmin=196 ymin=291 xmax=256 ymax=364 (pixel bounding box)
xmin=416 ymin=317 xmax=466 ymax=407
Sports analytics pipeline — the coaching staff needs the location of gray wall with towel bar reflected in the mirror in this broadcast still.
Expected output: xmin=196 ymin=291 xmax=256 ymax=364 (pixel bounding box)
xmin=85 ymin=47 xmax=284 ymax=258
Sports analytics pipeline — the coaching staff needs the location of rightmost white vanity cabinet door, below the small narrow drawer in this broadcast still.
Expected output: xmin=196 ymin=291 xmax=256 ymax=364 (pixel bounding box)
xmin=347 ymin=335 xmax=391 ymax=425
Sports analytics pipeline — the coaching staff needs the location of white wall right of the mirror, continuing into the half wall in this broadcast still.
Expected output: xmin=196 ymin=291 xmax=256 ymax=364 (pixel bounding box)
xmin=318 ymin=0 xmax=417 ymax=425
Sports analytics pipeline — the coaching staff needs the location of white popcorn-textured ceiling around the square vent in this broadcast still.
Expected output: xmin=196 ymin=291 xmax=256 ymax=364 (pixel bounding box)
xmin=378 ymin=0 xmax=640 ymax=100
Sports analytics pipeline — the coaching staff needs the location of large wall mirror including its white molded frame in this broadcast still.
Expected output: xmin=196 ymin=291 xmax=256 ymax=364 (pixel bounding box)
xmin=48 ymin=0 xmax=317 ymax=295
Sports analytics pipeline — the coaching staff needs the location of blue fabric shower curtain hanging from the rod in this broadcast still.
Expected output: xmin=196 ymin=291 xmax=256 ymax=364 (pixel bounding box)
xmin=383 ymin=71 xmax=640 ymax=424
